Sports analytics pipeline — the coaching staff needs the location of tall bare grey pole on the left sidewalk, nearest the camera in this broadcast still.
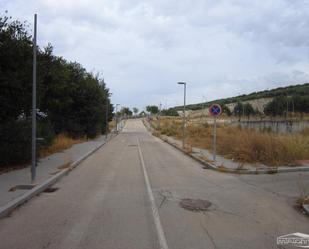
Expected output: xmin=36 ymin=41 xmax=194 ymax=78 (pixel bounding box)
xmin=31 ymin=14 xmax=37 ymax=183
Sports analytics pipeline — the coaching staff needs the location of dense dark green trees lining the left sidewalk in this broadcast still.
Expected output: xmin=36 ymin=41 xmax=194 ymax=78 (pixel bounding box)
xmin=0 ymin=15 xmax=113 ymax=166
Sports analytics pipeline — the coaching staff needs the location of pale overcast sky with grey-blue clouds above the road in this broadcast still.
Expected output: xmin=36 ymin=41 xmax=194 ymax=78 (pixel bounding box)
xmin=0 ymin=0 xmax=309 ymax=108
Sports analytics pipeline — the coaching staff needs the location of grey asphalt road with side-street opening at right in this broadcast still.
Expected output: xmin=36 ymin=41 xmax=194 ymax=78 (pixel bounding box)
xmin=0 ymin=120 xmax=309 ymax=249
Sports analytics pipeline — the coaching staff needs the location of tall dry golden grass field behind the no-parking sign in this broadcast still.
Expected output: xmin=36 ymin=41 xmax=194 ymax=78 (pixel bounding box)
xmin=155 ymin=118 xmax=309 ymax=166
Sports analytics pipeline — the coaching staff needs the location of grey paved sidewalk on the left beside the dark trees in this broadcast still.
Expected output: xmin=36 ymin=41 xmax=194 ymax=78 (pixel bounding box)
xmin=0 ymin=134 xmax=113 ymax=208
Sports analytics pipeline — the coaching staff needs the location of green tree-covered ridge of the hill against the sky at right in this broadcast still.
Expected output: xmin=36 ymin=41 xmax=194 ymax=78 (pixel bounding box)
xmin=173 ymin=83 xmax=309 ymax=110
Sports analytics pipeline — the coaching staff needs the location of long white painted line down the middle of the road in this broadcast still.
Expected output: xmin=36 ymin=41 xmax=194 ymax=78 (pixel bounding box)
xmin=137 ymin=139 xmax=168 ymax=249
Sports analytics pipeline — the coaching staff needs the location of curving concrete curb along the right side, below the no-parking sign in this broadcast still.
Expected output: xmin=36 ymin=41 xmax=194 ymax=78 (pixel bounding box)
xmin=143 ymin=120 xmax=309 ymax=174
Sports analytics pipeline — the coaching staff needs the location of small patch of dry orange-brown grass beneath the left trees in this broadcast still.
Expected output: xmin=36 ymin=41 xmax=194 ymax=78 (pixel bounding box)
xmin=40 ymin=134 xmax=87 ymax=157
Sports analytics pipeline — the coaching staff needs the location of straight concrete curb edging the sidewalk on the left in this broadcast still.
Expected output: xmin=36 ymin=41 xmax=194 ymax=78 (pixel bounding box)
xmin=0 ymin=134 xmax=117 ymax=218
